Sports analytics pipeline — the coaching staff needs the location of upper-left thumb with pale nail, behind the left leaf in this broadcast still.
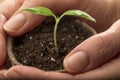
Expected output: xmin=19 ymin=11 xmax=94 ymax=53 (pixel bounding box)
xmin=3 ymin=0 xmax=46 ymax=36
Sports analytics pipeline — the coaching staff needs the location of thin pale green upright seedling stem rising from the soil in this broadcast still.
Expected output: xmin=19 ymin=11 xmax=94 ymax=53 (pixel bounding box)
xmin=54 ymin=18 xmax=59 ymax=53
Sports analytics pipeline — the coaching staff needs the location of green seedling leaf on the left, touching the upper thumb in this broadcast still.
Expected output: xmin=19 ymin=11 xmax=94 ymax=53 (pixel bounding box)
xmin=23 ymin=7 xmax=54 ymax=16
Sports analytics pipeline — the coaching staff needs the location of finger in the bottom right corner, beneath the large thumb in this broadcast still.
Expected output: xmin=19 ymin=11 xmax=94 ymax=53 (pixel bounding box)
xmin=76 ymin=56 xmax=120 ymax=80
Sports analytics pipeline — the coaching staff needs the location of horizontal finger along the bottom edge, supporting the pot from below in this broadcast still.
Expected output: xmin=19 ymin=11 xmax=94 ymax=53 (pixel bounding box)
xmin=4 ymin=66 xmax=72 ymax=80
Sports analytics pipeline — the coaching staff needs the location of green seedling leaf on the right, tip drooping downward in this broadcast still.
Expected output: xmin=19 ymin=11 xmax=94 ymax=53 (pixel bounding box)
xmin=62 ymin=10 xmax=96 ymax=22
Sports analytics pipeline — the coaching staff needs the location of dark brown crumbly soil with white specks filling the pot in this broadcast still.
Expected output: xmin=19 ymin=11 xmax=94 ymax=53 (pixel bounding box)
xmin=7 ymin=16 xmax=93 ymax=71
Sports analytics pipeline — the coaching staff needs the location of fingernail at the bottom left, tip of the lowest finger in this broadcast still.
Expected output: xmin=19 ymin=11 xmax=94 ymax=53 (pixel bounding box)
xmin=4 ymin=70 xmax=22 ymax=79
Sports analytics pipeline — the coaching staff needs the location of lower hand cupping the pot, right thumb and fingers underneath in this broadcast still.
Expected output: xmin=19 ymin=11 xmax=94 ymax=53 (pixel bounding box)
xmin=4 ymin=20 xmax=120 ymax=80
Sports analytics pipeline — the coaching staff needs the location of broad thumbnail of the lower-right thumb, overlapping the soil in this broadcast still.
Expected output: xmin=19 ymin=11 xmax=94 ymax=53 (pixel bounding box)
xmin=64 ymin=51 xmax=89 ymax=73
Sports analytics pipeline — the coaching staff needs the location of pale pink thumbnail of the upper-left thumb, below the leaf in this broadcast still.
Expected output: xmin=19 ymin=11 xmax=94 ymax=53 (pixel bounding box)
xmin=4 ymin=14 xmax=26 ymax=32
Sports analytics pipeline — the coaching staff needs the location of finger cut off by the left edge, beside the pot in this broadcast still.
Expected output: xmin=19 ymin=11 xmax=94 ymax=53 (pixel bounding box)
xmin=0 ymin=15 xmax=6 ymax=66
